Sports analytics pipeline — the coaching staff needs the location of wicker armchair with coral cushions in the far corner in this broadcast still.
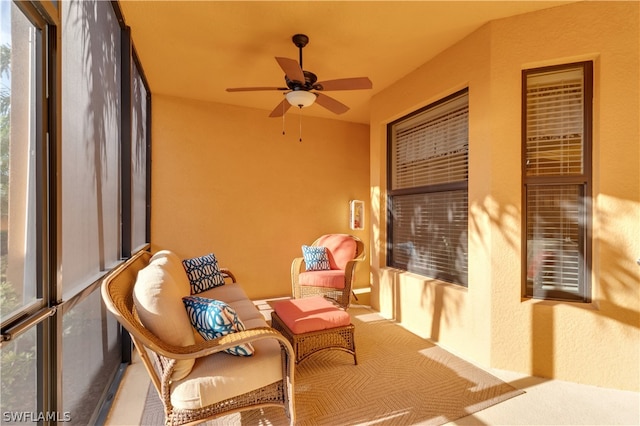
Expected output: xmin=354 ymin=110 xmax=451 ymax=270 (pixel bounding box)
xmin=291 ymin=234 xmax=365 ymax=309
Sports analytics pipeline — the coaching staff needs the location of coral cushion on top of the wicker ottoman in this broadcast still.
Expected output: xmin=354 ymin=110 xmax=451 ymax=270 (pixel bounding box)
xmin=274 ymin=296 xmax=351 ymax=334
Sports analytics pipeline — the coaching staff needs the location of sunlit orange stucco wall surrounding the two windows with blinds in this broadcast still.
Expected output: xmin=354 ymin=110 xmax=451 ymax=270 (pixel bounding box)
xmin=370 ymin=2 xmax=640 ymax=391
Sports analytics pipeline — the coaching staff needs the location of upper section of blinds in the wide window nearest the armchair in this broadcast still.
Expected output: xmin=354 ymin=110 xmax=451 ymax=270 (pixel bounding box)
xmin=391 ymin=93 xmax=469 ymax=189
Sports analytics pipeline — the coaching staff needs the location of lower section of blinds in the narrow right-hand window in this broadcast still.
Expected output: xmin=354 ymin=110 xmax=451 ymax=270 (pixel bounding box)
xmin=527 ymin=184 xmax=583 ymax=294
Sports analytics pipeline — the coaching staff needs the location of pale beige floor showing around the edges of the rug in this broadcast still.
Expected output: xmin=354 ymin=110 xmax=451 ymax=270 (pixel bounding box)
xmin=105 ymin=304 xmax=640 ymax=426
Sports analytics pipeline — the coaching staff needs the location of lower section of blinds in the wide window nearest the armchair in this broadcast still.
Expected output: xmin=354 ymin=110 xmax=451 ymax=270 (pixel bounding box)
xmin=391 ymin=190 xmax=468 ymax=286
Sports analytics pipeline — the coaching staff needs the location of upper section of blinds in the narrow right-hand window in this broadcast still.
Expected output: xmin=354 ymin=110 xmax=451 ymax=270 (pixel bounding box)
xmin=525 ymin=67 xmax=584 ymax=176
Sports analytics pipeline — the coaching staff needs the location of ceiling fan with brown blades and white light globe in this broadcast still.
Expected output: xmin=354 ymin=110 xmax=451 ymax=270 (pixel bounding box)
xmin=227 ymin=34 xmax=373 ymax=117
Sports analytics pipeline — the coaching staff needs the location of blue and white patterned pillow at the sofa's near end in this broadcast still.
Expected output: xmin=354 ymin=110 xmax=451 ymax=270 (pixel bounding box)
xmin=182 ymin=296 xmax=255 ymax=356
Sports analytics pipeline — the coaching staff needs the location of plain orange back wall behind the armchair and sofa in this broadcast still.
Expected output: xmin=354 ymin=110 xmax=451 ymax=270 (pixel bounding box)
xmin=151 ymin=95 xmax=369 ymax=300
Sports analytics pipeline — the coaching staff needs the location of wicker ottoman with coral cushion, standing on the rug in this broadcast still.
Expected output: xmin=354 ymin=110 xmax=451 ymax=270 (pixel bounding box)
xmin=271 ymin=296 xmax=358 ymax=364
